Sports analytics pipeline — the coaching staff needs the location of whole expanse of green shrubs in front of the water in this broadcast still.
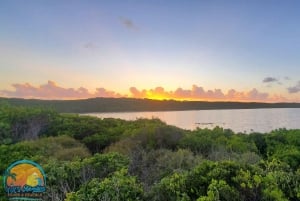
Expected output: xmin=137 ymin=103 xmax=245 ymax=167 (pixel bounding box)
xmin=0 ymin=103 xmax=300 ymax=201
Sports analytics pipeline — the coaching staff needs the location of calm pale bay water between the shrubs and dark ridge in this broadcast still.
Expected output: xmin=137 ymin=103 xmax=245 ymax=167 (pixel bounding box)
xmin=87 ymin=108 xmax=300 ymax=133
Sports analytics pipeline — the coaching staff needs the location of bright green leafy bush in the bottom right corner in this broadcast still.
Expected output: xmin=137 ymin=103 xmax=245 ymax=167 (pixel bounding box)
xmin=151 ymin=161 xmax=300 ymax=201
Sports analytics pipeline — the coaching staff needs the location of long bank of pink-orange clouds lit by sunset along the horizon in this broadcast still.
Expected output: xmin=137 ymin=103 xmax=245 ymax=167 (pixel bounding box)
xmin=0 ymin=81 xmax=300 ymax=102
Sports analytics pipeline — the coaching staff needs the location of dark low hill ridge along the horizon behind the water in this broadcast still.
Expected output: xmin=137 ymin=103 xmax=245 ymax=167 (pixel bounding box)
xmin=0 ymin=98 xmax=300 ymax=113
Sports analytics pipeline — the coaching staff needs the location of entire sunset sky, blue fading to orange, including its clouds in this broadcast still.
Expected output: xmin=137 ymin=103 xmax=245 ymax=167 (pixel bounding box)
xmin=0 ymin=0 xmax=300 ymax=102
